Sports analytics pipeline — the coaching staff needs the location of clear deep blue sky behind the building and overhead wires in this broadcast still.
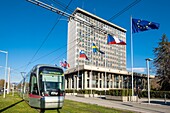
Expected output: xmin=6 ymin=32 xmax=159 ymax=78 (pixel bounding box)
xmin=0 ymin=0 xmax=170 ymax=82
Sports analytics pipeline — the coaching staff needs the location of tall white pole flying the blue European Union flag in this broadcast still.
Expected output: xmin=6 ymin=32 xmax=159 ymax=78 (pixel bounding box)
xmin=130 ymin=16 xmax=134 ymax=98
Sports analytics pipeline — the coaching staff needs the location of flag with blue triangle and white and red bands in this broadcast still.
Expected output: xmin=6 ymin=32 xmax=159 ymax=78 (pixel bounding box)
xmin=107 ymin=34 xmax=126 ymax=45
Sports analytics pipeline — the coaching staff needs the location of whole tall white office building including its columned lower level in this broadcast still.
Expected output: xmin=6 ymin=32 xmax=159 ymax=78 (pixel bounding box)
xmin=65 ymin=8 xmax=146 ymax=90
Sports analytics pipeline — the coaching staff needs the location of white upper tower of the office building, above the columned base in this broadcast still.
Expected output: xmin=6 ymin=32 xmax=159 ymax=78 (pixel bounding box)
xmin=67 ymin=7 xmax=126 ymax=70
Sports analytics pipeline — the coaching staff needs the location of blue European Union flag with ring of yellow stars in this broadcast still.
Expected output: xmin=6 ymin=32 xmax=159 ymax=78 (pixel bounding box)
xmin=132 ymin=19 xmax=160 ymax=33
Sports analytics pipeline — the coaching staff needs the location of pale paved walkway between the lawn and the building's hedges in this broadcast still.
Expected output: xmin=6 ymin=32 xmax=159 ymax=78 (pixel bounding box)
xmin=65 ymin=96 xmax=170 ymax=113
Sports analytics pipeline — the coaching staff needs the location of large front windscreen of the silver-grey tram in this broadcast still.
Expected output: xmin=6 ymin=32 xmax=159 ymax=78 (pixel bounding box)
xmin=40 ymin=66 xmax=64 ymax=96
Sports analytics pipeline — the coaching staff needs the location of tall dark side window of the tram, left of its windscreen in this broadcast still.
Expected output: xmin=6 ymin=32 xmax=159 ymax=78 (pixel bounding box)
xmin=30 ymin=75 xmax=38 ymax=95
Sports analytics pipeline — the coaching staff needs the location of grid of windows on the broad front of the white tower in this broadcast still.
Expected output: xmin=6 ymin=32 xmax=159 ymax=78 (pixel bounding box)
xmin=67 ymin=13 xmax=126 ymax=69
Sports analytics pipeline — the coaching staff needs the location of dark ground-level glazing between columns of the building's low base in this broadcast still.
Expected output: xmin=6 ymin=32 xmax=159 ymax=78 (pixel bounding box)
xmin=66 ymin=72 xmax=142 ymax=88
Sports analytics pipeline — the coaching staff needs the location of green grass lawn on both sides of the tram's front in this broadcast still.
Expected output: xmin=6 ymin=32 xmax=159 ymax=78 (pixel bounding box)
xmin=0 ymin=94 xmax=133 ymax=113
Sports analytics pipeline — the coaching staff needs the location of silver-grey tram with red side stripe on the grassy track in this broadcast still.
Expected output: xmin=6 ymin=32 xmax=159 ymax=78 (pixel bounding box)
xmin=18 ymin=64 xmax=65 ymax=110
